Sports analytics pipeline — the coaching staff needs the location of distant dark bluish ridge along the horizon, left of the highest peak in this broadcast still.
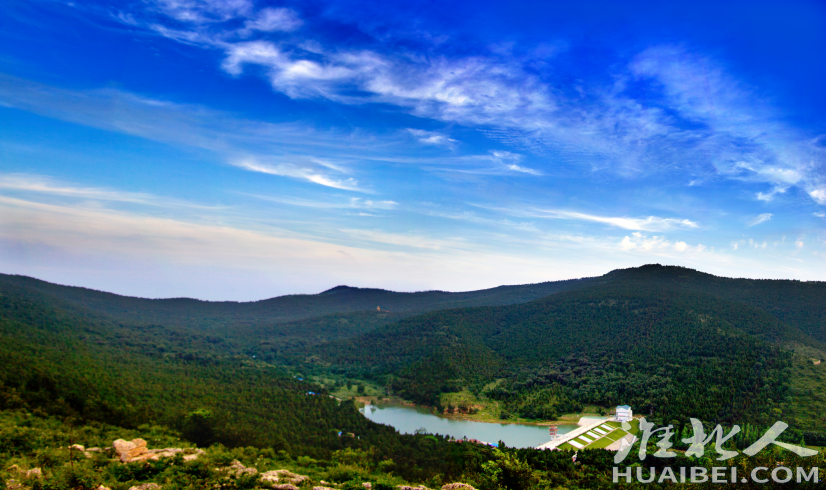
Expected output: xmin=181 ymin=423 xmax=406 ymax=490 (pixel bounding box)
xmin=0 ymin=274 xmax=590 ymax=330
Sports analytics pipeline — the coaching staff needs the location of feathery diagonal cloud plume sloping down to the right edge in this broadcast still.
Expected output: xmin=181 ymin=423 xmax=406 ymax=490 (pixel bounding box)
xmin=630 ymin=46 xmax=826 ymax=200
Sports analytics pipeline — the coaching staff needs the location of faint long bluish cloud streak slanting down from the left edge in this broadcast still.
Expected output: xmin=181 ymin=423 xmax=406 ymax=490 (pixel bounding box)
xmin=0 ymin=74 xmax=386 ymax=192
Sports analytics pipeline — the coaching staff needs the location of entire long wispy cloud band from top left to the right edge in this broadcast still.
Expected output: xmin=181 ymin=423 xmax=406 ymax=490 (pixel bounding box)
xmin=132 ymin=1 xmax=826 ymax=204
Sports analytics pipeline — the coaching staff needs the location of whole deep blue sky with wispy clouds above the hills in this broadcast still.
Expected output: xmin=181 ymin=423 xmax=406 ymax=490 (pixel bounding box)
xmin=0 ymin=0 xmax=826 ymax=300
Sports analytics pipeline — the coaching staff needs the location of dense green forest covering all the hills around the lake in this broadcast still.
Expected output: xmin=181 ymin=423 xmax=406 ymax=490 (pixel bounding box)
xmin=0 ymin=265 xmax=826 ymax=488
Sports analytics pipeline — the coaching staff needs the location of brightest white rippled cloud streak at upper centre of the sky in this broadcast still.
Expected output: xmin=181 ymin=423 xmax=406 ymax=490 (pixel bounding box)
xmin=216 ymin=37 xmax=555 ymax=127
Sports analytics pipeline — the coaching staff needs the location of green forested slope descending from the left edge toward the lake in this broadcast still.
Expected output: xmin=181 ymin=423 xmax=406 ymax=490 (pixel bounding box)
xmin=0 ymin=276 xmax=502 ymax=482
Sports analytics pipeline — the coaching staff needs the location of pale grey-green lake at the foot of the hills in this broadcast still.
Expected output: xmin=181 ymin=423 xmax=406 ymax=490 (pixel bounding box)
xmin=361 ymin=405 xmax=577 ymax=448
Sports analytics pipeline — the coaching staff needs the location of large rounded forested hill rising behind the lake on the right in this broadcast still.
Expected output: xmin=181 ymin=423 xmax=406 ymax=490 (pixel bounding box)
xmin=308 ymin=266 xmax=826 ymax=430
